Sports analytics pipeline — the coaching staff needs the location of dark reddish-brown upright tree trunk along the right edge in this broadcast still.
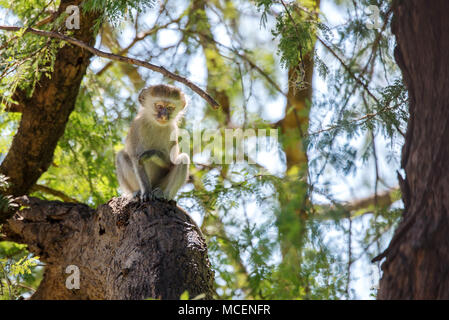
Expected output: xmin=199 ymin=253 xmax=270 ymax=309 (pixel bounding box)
xmin=378 ymin=0 xmax=449 ymax=299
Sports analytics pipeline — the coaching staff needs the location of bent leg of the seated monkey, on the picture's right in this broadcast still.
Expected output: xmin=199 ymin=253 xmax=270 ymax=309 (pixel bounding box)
xmin=161 ymin=153 xmax=190 ymax=200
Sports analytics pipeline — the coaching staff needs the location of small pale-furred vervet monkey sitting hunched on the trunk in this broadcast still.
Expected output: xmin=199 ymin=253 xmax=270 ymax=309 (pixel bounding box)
xmin=115 ymin=84 xmax=190 ymax=201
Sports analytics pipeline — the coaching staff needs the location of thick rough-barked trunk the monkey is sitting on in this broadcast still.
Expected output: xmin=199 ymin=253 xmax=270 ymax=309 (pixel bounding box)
xmin=3 ymin=197 xmax=213 ymax=299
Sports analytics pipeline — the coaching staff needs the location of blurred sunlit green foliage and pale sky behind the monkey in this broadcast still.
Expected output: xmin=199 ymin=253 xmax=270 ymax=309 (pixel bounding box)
xmin=0 ymin=0 xmax=408 ymax=299
